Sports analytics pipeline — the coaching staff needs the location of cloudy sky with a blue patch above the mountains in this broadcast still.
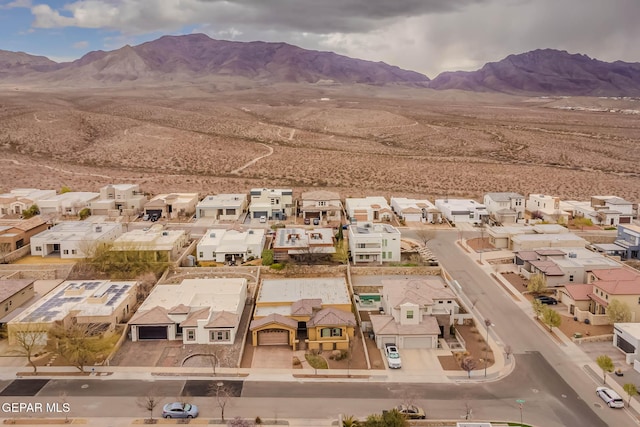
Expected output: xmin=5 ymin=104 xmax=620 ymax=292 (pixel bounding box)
xmin=0 ymin=0 xmax=640 ymax=78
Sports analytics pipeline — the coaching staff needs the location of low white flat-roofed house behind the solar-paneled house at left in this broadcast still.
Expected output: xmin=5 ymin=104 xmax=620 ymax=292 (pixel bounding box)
xmin=31 ymin=221 xmax=122 ymax=258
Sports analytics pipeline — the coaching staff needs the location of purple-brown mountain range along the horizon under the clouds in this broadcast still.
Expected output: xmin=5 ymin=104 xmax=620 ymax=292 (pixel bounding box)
xmin=0 ymin=34 xmax=640 ymax=96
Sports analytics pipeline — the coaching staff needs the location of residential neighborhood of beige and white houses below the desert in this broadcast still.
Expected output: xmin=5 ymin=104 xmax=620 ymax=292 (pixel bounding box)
xmin=0 ymin=184 xmax=640 ymax=427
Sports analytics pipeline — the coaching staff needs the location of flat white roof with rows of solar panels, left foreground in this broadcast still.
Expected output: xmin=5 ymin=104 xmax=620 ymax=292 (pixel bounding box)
xmin=12 ymin=280 xmax=136 ymax=323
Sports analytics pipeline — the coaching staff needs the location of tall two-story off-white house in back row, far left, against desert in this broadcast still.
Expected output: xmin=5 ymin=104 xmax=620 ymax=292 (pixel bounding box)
xmin=90 ymin=184 xmax=147 ymax=216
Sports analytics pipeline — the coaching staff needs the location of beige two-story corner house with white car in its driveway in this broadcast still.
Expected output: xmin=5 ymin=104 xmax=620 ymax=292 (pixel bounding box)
xmin=371 ymin=276 xmax=459 ymax=349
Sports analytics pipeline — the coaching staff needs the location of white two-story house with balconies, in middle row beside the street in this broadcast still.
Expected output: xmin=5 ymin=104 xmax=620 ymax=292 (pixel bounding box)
xmin=349 ymin=222 xmax=401 ymax=265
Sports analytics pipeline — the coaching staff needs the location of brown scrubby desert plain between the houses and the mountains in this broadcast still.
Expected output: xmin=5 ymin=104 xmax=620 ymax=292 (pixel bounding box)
xmin=0 ymin=84 xmax=640 ymax=201
